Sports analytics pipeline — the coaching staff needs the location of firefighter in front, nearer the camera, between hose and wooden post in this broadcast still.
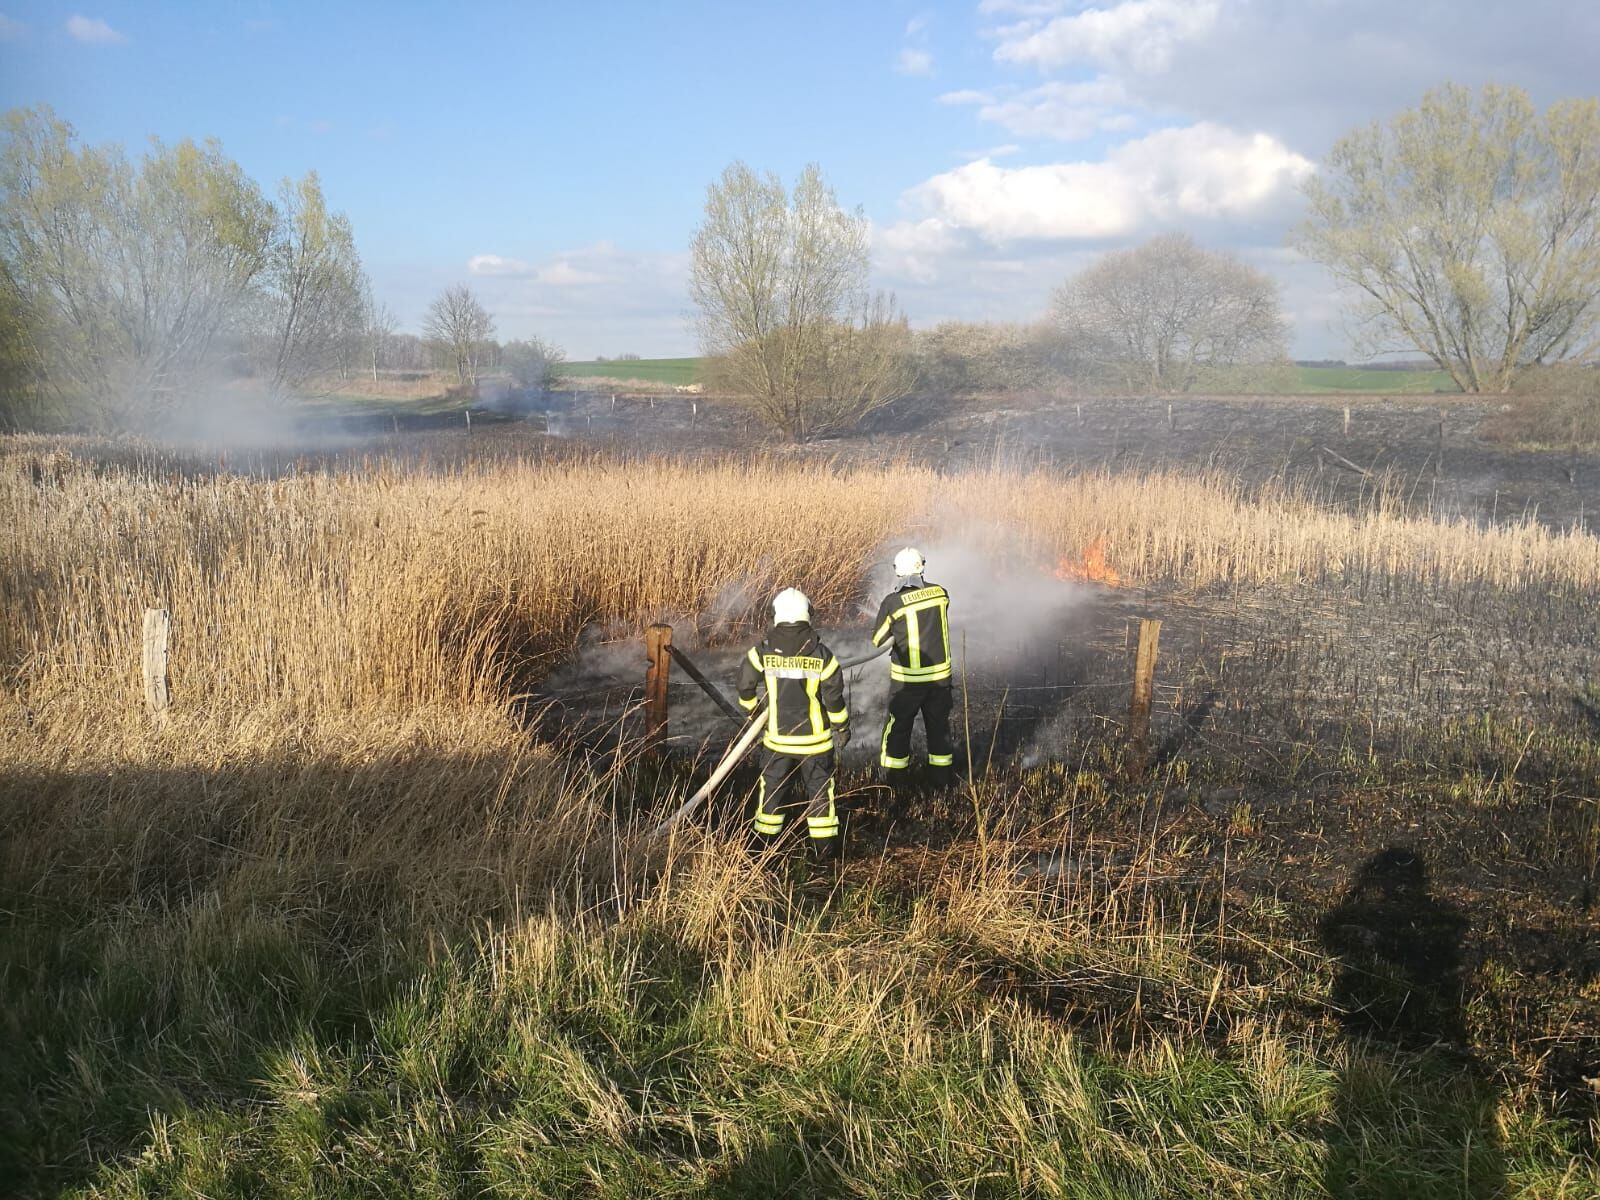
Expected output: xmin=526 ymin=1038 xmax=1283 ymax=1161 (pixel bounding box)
xmin=739 ymin=587 xmax=850 ymax=859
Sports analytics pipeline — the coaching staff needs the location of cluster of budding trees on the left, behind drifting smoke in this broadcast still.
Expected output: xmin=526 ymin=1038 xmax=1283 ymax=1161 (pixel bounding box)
xmin=0 ymin=107 xmax=562 ymax=427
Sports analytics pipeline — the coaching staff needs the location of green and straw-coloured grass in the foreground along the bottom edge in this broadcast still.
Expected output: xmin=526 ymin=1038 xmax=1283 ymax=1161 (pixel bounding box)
xmin=0 ymin=752 xmax=1600 ymax=1200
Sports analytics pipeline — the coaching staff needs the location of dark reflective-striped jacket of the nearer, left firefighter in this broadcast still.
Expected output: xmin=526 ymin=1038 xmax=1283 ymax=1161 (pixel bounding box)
xmin=739 ymin=622 xmax=850 ymax=754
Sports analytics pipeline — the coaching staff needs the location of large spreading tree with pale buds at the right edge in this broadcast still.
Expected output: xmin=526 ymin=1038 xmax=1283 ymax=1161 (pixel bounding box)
xmin=1294 ymin=85 xmax=1600 ymax=392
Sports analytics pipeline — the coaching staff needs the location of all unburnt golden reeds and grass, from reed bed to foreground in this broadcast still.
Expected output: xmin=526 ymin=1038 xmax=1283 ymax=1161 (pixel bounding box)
xmin=0 ymin=440 xmax=1600 ymax=1197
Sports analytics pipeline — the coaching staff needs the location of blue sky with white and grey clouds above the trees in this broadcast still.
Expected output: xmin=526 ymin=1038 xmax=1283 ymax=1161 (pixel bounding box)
xmin=0 ymin=0 xmax=1600 ymax=357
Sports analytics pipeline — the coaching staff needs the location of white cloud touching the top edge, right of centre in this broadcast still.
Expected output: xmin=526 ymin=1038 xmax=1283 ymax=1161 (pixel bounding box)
xmin=995 ymin=0 xmax=1222 ymax=75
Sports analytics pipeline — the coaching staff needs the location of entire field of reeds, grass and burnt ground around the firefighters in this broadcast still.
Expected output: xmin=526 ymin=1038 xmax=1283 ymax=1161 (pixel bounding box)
xmin=0 ymin=397 xmax=1600 ymax=1197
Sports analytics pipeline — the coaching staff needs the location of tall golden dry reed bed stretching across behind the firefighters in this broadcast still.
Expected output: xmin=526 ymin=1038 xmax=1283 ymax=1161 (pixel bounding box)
xmin=0 ymin=442 xmax=1600 ymax=748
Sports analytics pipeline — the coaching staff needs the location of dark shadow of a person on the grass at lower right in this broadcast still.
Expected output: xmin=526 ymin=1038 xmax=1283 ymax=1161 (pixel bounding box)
xmin=1320 ymin=845 xmax=1506 ymax=1200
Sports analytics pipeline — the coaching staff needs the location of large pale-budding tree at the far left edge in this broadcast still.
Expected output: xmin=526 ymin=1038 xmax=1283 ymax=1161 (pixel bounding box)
xmin=0 ymin=109 xmax=274 ymax=424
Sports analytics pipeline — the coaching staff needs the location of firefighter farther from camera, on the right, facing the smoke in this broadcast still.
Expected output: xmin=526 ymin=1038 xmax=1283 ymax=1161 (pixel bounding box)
xmin=872 ymin=546 xmax=955 ymax=787
